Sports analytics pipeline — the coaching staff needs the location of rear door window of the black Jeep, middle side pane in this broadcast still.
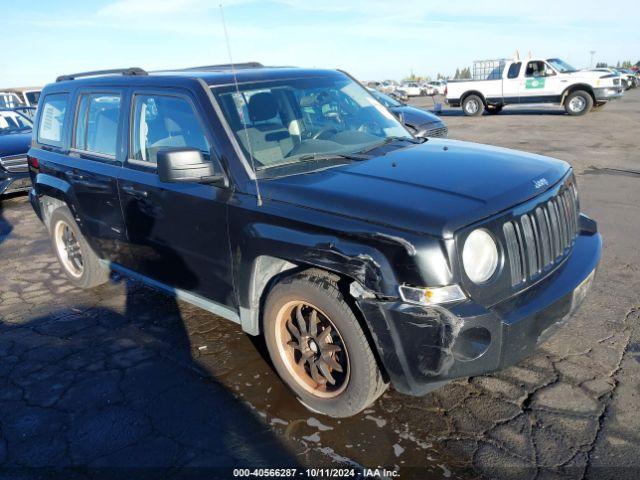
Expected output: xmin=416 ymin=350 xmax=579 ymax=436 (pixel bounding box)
xmin=74 ymin=93 xmax=120 ymax=157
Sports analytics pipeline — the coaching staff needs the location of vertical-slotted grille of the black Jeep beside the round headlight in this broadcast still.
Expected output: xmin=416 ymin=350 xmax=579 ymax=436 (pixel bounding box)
xmin=502 ymin=183 xmax=579 ymax=286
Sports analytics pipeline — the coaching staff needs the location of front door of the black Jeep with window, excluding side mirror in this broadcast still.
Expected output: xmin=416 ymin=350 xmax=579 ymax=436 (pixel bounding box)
xmin=119 ymin=89 xmax=235 ymax=306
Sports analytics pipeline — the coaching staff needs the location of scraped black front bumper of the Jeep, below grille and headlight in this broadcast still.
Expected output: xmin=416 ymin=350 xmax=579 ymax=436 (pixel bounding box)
xmin=357 ymin=219 xmax=602 ymax=395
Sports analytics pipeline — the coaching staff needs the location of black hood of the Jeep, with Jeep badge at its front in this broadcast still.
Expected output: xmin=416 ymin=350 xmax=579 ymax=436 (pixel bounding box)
xmin=261 ymin=139 xmax=570 ymax=238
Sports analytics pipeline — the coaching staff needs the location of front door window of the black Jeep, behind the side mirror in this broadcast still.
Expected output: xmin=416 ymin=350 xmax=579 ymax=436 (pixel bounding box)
xmin=131 ymin=95 xmax=211 ymax=164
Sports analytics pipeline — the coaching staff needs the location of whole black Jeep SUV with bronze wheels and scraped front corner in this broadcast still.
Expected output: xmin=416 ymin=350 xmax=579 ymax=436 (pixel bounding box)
xmin=29 ymin=64 xmax=601 ymax=417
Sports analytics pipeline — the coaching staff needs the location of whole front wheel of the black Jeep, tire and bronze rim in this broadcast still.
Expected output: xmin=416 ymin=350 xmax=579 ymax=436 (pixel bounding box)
xmin=263 ymin=270 xmax=387 ymax=417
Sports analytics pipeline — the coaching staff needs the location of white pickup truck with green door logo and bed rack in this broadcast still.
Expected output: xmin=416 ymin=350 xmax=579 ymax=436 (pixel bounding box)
xmin=446 ymin=58 xmax=623 ymax=116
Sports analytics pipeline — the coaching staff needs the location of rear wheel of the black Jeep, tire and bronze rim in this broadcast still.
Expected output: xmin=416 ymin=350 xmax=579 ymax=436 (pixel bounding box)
xmin=49 ymin=207 xmax=109 ymax=289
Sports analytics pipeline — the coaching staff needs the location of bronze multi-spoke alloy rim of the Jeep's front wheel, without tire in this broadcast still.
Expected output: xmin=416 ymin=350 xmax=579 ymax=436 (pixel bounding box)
xmin=275 ymin=301 xmax=351 ymax=398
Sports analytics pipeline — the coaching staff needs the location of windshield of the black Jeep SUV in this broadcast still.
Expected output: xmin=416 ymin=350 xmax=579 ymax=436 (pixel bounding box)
xmin=213 ymin=74 xmax=413 ymax=171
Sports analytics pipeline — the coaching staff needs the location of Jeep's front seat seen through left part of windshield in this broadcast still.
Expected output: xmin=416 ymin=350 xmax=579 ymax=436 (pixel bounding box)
xmin=236 ymin=92 xmax=293 ymax=166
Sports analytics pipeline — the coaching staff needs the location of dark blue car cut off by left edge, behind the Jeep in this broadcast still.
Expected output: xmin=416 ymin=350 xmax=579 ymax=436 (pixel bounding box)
xmin=0 ymin=109 xmax=32 ymax=195
